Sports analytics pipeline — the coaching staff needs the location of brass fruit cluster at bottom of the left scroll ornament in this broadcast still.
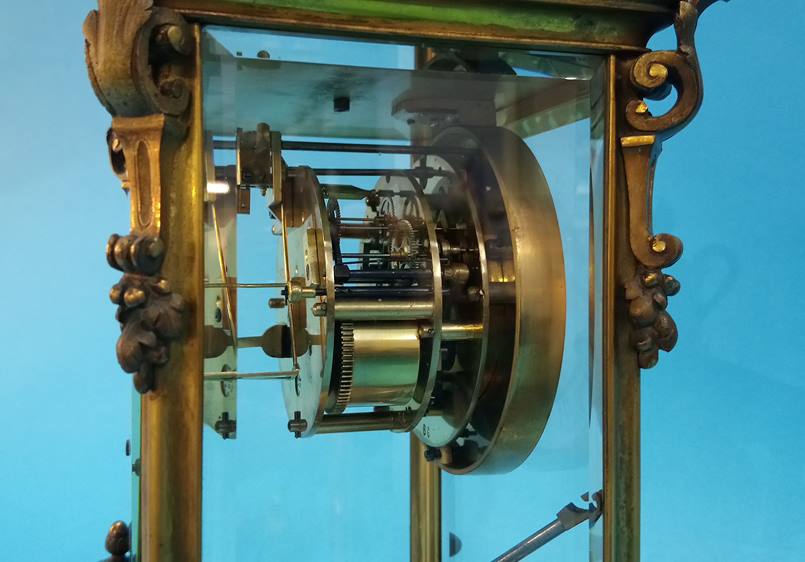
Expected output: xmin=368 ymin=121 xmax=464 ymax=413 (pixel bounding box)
xmin=106 ymin=234 xmax=185 ymax=393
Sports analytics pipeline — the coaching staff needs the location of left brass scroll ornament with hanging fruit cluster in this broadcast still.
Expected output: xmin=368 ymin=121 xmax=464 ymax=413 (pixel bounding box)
xmin=84 ymin=0 xmax=193 ymax=393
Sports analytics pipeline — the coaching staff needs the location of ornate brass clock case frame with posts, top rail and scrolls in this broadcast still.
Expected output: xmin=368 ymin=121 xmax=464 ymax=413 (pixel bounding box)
xmin=84 ymin=0 xmax=715 ymax=562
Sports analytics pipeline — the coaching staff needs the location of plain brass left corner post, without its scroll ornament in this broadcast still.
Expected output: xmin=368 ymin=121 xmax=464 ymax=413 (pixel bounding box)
xmin=140 ymin=28 xmax=205 ymax=562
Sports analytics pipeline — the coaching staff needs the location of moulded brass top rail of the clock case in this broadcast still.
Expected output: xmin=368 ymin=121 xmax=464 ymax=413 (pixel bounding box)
xmin=155 ymin=0 xmax=680 ymax=53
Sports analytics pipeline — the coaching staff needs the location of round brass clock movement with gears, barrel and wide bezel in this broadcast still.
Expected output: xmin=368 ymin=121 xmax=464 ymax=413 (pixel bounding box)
xmin=245 ymin=108 xmax=565 ymax=473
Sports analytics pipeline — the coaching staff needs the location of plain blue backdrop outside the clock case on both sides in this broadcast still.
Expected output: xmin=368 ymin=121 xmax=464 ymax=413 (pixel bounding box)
xmin=0 ymin=0 xmax=805 ymax=562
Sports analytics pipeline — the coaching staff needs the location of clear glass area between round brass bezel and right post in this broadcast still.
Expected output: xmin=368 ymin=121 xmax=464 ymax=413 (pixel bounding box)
xmin=443 ymin=53 xmax=604 ymax=561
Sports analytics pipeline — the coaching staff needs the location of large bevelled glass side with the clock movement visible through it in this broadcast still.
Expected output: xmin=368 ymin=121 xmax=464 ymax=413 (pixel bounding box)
xmin=203 ymin=29 xmax=602 ymax=560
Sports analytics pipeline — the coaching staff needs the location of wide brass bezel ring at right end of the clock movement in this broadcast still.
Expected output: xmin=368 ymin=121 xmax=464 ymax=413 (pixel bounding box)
xmin=418 ymin=128 xmax=565 ymax=473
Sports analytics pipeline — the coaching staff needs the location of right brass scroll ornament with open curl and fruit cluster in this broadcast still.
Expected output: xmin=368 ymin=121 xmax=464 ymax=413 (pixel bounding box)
xmin=620 ymin=0 xmax=713 ymax=369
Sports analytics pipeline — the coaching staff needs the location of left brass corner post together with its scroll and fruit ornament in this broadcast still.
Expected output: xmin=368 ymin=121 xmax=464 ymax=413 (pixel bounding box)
xmin=84 ymin=0 xmax=204 ymax=561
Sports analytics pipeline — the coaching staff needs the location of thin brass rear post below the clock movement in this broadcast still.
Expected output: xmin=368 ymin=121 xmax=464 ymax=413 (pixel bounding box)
xmin=410 ymin=434 xmax=442 ymax=562
